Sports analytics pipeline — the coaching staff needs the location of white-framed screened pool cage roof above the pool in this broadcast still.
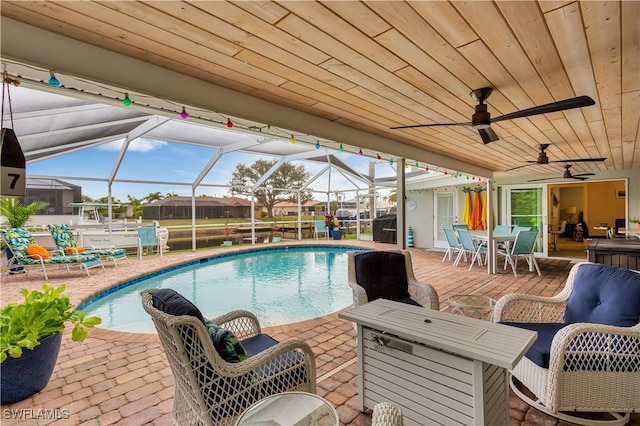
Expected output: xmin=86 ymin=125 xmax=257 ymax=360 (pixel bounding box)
xmin=3 ymin=73 xmax=476 ymax=201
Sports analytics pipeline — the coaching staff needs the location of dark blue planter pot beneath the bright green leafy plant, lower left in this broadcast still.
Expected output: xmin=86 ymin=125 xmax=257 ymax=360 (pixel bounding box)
xmin=0 ymin=333 xmax=62 ymax=405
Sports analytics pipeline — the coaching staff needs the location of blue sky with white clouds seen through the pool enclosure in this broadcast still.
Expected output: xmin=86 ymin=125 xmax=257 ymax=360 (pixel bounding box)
xmin=27 ymin=136 xmax=395 ymax=202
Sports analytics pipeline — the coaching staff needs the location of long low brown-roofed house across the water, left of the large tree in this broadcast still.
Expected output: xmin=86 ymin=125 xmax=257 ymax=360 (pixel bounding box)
xmin=142 ymin=197 xmax=262 ymax=220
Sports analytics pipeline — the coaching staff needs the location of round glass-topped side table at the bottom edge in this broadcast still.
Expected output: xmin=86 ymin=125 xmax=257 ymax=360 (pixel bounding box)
xmin=236 ymin=392 xmax=340 ymax=426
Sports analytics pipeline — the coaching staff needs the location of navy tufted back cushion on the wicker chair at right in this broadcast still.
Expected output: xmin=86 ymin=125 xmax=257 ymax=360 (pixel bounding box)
xmin=564 ymin=264 xmax=640 ymax=327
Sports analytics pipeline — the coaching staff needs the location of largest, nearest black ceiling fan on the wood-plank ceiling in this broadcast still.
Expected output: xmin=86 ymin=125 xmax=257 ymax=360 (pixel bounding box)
xmin=391 ymin=87 xmax=596 ymax=145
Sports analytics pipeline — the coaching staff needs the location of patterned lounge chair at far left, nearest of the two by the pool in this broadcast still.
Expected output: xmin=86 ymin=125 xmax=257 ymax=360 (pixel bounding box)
xmin=0 ymin=228 xmax=104 ymax=280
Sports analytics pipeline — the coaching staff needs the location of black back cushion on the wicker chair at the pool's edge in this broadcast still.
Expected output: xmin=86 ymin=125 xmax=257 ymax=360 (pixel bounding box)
xmin=355 ymin=251 xmax=410 ymax=302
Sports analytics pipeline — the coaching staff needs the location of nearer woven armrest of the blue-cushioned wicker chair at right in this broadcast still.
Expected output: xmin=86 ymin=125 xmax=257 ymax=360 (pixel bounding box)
xmin=549 ymin=323 xmax=640 ymax=374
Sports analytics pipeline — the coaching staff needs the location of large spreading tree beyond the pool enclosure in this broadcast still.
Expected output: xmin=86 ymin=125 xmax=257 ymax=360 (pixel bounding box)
xmin=229 ymin=160 xmax=312 ymax=217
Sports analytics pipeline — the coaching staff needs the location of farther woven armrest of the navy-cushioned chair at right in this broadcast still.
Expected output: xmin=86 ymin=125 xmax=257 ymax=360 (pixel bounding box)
xmin=493 ymin=293 xmax=567 ymax=323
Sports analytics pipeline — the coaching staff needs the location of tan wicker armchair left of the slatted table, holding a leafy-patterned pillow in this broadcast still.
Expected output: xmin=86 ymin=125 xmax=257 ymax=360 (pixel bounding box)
xmin=142 ymin=289 xmax=316 ymax=425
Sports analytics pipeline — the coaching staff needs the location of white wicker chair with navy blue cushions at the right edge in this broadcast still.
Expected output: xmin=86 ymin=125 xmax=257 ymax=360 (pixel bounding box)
xmin=493 ymin=262 xmax=640 ymax=424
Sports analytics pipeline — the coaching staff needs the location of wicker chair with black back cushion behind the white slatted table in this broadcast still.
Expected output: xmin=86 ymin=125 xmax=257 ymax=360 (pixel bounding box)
xmin=347 ymin=250 xmax=440 ymax=310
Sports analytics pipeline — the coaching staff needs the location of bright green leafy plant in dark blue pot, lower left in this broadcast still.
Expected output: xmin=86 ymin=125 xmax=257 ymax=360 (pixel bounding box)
xmin=0 ymin=284 xmax=102 ymax=405
